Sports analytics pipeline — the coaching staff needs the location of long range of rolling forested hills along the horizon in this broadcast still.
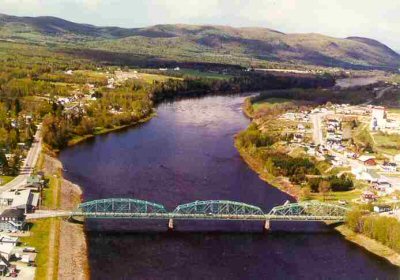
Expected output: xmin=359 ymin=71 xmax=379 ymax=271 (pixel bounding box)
xmin=0 ymin=14 xmax=400 ymax=69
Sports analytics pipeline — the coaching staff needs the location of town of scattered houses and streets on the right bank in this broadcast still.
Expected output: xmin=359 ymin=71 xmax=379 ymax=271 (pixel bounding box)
xmin=260 ymin=100 xmax=400 ymax=212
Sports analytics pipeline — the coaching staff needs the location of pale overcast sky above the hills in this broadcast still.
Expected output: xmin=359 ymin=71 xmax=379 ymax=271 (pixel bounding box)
xmin=0 ymin=0 xmax=400 ymax=50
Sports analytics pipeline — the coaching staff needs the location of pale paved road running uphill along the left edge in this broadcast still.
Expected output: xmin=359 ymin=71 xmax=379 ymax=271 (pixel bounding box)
xmin=0 ymin=126 xmax=42 ymax=193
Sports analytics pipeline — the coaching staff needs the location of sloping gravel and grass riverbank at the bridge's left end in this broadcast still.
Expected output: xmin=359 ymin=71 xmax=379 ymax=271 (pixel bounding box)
xmin=35 ymin=154 xmax=89 ymax=280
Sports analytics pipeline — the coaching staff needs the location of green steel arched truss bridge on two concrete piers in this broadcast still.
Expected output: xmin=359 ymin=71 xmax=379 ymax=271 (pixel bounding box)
xmin=27 ymin=198 xmax=349 ymax=229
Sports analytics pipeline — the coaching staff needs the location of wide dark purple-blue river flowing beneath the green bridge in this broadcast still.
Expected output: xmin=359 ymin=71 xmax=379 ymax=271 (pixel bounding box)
xmin=60 ymin=96 xmax=400 ymax=279
